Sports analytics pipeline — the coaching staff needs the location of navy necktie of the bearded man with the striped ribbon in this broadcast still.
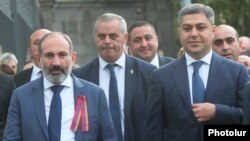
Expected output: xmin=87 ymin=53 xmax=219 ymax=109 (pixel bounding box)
xmin=48 ymin=85 xmax=64 ymax=141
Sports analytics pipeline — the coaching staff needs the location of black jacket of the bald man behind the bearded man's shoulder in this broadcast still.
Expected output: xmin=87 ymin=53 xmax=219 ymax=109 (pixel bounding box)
xmin=14 ymin=67 xmax=33 ymax=87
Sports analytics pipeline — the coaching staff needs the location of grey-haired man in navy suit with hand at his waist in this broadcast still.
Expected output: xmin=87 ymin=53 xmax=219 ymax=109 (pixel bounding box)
xmin=145 ymin=3 xmax=249 ymax=141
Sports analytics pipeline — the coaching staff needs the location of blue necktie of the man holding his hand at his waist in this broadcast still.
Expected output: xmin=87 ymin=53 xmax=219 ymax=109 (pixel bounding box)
xmin=192 ymin=61 xmax=205 ymax=103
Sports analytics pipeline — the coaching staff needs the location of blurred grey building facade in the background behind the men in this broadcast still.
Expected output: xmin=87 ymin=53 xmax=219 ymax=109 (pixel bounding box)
xmin=0 ymin=0 xmax=177 ymax=69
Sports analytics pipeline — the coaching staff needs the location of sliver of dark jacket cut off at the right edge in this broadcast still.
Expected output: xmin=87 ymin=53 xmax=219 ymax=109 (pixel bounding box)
xmin=243 ymin=82 xmax=250 ymax=124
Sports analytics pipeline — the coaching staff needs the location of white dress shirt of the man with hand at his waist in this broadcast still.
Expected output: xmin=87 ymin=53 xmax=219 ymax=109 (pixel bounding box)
xmin=185 ymin=50 xmax=213 ymax=103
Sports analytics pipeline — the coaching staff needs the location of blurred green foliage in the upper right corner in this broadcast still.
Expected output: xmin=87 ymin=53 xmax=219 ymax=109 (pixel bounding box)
xmin=192 ymin=0 xmax=250 ymax=37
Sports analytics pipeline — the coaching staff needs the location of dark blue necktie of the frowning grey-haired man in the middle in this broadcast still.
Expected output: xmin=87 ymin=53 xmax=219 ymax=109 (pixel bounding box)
xmin=107 ymin=64 xmax=123 ymax=141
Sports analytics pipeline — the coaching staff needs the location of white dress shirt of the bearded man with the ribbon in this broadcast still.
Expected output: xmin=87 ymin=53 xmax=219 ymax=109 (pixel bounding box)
xmin=43 ymin=76 xmax=75 ymax=141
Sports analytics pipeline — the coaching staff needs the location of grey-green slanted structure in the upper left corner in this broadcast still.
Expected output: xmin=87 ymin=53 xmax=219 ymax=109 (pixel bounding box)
xmin=0 ymin=0 xmax=42 ymax=69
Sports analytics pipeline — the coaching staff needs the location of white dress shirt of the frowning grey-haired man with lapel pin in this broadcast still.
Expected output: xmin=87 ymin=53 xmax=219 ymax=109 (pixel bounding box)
xmin=99 ymin=53 xmax=126 ymax=136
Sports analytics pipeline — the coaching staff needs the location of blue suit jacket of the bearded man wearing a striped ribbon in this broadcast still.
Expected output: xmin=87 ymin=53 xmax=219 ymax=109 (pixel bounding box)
xmin=3 ymin=76 xmax=117 ymax=141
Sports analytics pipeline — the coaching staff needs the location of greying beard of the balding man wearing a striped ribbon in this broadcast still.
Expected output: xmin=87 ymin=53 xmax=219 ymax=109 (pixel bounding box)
xmin=42 ymin=65 xmax=72 ymax=84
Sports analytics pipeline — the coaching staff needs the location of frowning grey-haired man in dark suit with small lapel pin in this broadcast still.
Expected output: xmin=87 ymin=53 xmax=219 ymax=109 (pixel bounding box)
xmin=74 ymin=13 xmax=156 ymax=141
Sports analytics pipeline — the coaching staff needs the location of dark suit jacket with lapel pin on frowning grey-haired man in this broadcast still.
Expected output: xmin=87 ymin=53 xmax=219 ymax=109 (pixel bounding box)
xmin=74 ymin=55 xmax=156 ymax=141
